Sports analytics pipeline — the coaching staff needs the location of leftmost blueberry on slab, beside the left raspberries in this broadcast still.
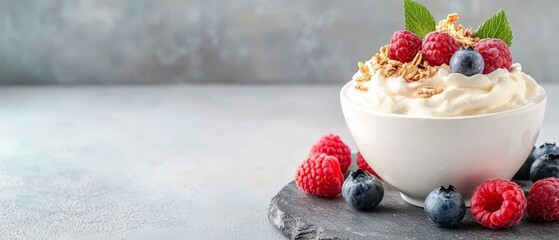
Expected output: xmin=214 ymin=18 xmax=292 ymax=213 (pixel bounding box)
xmin=342 ymin=169 xmax=384 ymax=210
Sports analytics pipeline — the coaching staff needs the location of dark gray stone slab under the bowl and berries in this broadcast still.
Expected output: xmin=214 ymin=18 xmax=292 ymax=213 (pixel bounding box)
xmin=268 ymin=179 xmax=559 ymax=239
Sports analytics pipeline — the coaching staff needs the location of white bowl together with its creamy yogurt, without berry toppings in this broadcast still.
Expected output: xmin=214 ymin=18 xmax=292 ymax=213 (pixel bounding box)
xmin=340 ymin=63 xmax=547 ymax=206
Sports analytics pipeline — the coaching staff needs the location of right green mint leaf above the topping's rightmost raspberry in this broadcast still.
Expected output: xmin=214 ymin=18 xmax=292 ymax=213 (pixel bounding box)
xmin=476 ymin=9 xmax=512 ymax=46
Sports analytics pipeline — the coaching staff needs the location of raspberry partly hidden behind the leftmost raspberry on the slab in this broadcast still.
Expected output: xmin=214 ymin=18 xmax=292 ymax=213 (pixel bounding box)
xmin=309 ymin=134 xmax=351 ymax=173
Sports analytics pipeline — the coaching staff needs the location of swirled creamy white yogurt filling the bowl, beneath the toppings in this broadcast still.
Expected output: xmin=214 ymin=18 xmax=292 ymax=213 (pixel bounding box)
xmin=347 ymin=62 xmax=542 ymax=116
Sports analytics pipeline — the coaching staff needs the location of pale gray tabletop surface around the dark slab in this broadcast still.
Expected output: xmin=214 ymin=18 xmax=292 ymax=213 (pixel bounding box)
xmin=0 ymin=84 xmax=559 ymax=239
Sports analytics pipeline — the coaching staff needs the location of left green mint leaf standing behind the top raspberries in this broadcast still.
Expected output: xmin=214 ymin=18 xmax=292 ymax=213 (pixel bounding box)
xmin=404 ymin=0 xmax=437 ymax=38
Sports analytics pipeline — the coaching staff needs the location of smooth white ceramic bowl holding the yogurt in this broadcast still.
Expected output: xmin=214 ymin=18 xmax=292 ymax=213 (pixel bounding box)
xmin=340 ymin=82 xmax=547 ymax=207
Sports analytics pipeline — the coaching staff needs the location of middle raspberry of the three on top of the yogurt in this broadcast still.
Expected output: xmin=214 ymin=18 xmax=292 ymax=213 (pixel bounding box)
xmin=421 ymin=32 xmax=460 ymax=66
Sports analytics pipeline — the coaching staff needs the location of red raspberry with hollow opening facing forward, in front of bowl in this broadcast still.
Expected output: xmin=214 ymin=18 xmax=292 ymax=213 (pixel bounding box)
xmin=470 ymin=178 xmax=526 ymax=229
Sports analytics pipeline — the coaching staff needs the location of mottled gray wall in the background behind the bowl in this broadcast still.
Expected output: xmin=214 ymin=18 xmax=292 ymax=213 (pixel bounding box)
xmin=0 ymin=0 xmax=559 ymax=84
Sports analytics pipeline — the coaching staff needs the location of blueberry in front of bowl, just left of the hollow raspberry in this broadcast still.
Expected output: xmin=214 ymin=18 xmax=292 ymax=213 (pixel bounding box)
xmin=423 ymin=185 xmax=466 ymax=227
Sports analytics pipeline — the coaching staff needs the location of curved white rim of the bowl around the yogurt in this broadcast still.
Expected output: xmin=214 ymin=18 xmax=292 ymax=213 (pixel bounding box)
xmin=340 ymin=80 xmax=547 ymax=120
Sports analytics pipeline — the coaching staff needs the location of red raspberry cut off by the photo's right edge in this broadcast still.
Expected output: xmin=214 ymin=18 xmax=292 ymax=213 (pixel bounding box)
xmin=527 ymin=178 xmax=559 ymax=222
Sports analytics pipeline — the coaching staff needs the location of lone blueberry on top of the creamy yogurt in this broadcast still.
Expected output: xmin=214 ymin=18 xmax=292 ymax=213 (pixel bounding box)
xmin=450 ymin=47 xmax=485 ymax=76
